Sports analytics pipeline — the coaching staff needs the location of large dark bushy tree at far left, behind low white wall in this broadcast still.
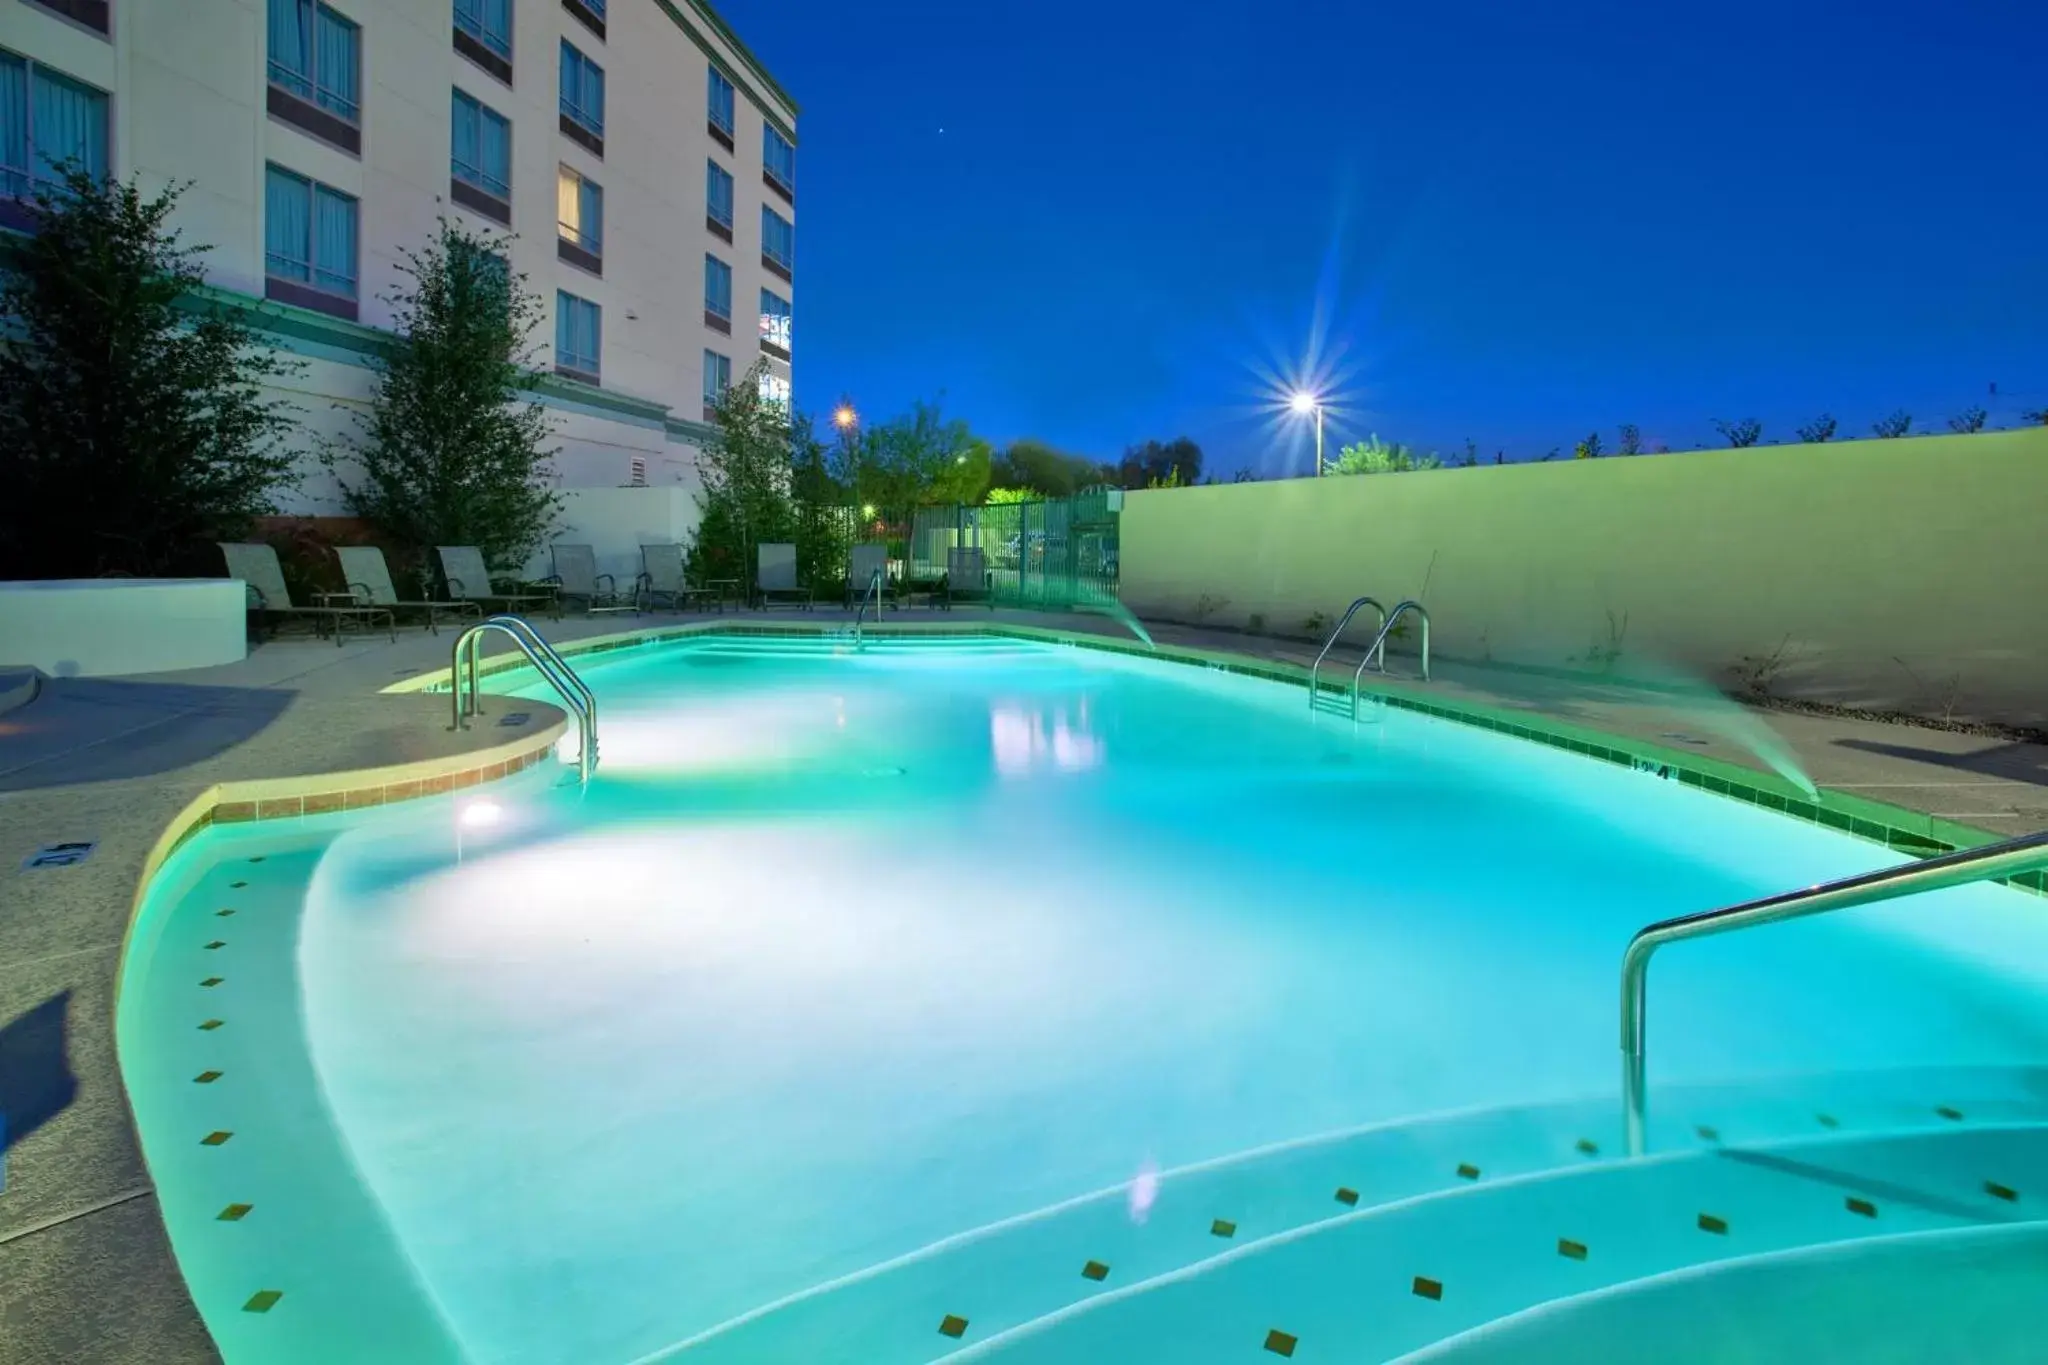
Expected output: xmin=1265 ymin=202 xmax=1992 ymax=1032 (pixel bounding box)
xmin=0 ymin=164 xmax=299 ymax=579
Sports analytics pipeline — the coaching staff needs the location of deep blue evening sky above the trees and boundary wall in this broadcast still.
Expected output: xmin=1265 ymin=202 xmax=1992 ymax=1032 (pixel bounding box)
xmin=721 ymin=0 xmax=2048 ymax=475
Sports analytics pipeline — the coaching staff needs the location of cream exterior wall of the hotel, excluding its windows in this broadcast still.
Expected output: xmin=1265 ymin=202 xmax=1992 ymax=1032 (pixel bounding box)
xmin=0 ymin=0 xmax=795 ymax=514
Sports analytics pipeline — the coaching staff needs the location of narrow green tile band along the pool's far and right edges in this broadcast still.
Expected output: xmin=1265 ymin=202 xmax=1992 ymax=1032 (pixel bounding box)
xmin=385 ymin=620 xmax=2048 ymax=894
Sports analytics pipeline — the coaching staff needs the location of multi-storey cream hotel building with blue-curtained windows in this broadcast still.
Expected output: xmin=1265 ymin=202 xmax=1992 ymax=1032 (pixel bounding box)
xmin=0 ymin=0 xmax=797 ymax=501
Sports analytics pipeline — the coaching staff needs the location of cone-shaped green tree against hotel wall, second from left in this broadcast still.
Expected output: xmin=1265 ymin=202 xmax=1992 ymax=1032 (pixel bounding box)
xmin=322 ymin=219 xmax=559 ymax=567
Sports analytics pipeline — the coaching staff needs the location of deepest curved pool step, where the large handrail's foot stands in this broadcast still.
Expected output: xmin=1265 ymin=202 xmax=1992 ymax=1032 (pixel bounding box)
xmin=663 ymin=1068 xmax=2048 ymax=1365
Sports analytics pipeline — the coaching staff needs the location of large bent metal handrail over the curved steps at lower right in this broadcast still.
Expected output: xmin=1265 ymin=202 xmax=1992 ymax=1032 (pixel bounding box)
xmin=1622 ymin=833 xmax=2048 ymax=1156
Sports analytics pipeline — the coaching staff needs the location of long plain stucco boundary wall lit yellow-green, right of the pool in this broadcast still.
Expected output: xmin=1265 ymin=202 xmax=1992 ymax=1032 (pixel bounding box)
xmin=1120 ymin=428 xmax=2048 ymax=726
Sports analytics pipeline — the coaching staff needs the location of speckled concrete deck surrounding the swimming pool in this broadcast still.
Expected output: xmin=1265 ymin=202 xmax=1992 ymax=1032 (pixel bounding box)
xmin=0 ymin=608 xmax=2048 ymax=1365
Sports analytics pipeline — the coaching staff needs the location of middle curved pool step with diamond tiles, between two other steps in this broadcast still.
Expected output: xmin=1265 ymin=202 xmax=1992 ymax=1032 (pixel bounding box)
xmin=958 ymin=1124 xmax=2048 ymax=1365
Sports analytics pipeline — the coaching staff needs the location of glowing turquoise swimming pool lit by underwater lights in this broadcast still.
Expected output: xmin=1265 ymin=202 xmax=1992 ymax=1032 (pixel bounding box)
xmin=119 ymin=636 xmax=2048 ymax=1365
